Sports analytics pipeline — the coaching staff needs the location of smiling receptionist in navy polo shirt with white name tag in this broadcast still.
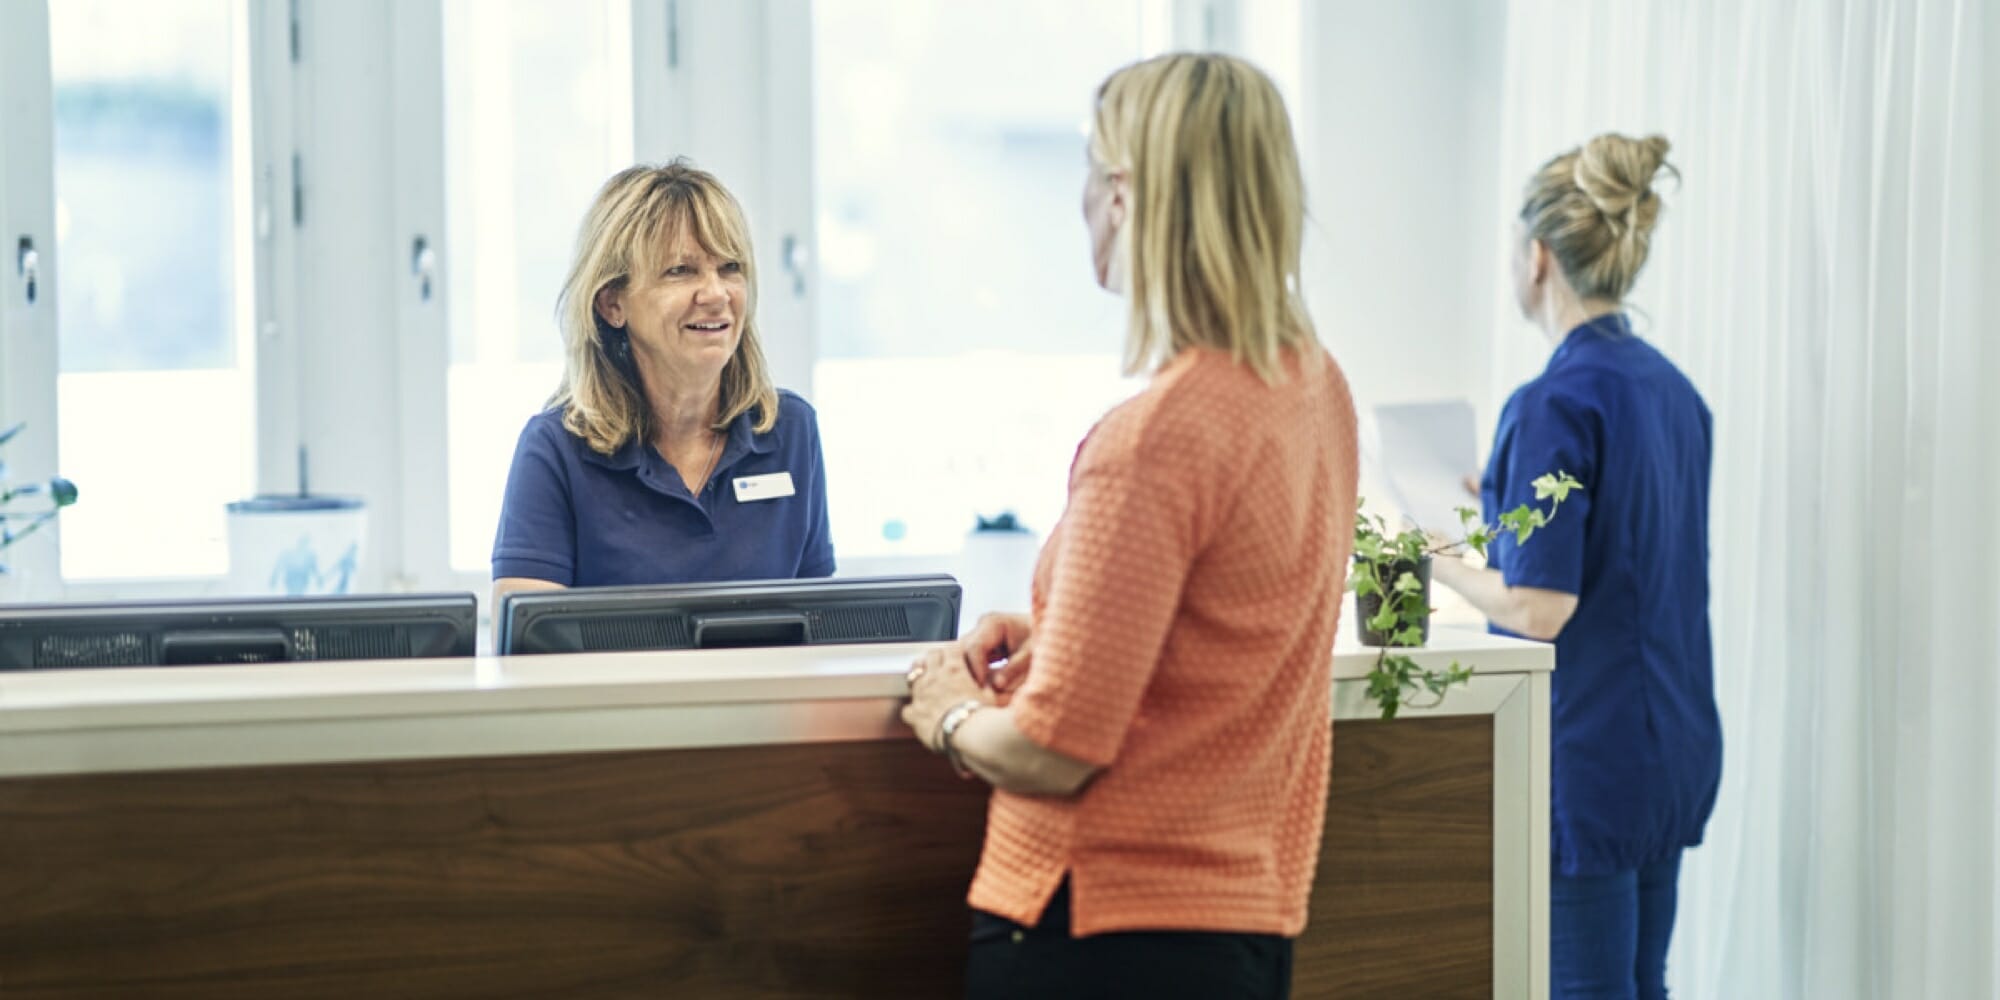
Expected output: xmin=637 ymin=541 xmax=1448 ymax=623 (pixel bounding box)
xmin=494 ymin=160 xmax=834 ymax=600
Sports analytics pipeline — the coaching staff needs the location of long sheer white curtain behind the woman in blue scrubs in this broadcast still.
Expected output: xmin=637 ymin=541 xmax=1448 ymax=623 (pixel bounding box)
xmin=1492 ymin=0 xmax=2000 ymax=1000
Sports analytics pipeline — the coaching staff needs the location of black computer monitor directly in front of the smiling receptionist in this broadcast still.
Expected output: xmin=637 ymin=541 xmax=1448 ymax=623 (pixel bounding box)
xmin=500 ymin=576 xmax=958 ymax=654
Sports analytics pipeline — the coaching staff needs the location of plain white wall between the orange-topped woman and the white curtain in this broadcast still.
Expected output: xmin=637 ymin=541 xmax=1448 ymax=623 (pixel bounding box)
xmin=1300 ymin=0 xmax=1504 ymax=418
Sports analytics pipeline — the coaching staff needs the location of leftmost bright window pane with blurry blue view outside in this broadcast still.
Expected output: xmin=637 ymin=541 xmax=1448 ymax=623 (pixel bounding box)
xmin=50 ymin=0 xmax=256 ymax=580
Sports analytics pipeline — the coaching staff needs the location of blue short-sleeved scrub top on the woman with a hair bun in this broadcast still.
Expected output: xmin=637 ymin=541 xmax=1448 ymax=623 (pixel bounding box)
xmin=1480 ymin=314 xmax=1722 ymax=876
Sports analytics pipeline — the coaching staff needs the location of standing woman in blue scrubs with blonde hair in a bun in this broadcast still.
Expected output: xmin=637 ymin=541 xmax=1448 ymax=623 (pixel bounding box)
xmin=1436 ymin=134 xmax=1722 ymax=1000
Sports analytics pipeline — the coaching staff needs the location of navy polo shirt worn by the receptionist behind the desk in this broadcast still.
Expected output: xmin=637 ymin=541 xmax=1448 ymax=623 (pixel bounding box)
xmin=494 ymin=390 xmax=834 ymax=586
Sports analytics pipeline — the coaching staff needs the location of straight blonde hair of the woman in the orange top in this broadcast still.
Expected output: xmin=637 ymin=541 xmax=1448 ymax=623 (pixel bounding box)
xmin=1090 ymin=54 xmax=1314 ymax=382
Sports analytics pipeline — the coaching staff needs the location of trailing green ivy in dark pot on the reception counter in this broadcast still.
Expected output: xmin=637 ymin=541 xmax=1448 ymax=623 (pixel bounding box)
xmin=1348 ymin=472 xmax=1584 ymax=718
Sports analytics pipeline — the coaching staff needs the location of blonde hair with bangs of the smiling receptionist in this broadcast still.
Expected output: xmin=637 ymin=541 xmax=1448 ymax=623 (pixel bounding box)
xmin=548 ymin=160 xmax=778 ymax=454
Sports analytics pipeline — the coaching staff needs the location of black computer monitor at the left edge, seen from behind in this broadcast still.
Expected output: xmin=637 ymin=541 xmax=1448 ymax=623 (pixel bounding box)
xmin=0 ymin=594 xmax=478 ymax=670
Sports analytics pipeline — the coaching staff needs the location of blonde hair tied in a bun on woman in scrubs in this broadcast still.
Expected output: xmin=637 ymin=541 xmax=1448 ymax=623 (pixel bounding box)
xmin=1520 ymin=132 xmax=1680 ymax=302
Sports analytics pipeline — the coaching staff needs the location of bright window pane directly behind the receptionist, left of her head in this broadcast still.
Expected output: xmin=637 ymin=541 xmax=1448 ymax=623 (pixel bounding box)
xmin=444 ymin=0 xmax=632 ymax=574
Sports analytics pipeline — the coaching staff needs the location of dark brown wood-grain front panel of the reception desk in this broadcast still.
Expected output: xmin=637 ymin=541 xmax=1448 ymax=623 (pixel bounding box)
xmin=0 ymin=718 xmax=1492 ymax=998
